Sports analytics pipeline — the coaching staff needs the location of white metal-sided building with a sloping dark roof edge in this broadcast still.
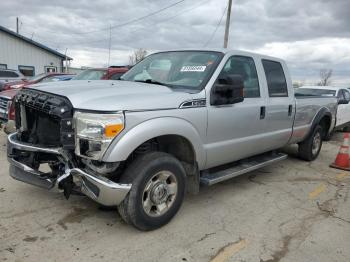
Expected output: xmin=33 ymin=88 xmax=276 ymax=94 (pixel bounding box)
xmin=0 ymin=26 xmax=73 ymax=76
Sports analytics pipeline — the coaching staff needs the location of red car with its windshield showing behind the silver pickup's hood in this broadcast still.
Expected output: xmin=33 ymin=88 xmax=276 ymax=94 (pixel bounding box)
xmin=72 ymin=67 xmax=129 ymax=80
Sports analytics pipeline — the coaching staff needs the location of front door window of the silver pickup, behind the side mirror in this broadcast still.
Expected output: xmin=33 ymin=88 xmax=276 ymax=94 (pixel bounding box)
xmin=219 ymin=56 xmax=260 ymax=98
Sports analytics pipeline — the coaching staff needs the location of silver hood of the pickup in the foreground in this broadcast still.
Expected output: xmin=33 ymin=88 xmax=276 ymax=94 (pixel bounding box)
xmin=30 ymin=80 xmax=192 ymax=111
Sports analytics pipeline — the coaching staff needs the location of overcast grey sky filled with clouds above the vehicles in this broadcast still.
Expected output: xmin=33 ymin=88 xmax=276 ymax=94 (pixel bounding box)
xmin=0 ymin=0 xmax=350 ymax=84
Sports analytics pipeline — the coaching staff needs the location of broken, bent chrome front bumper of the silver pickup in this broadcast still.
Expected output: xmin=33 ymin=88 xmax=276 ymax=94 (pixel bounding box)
xmin=7 ymin=133 xmax=131 ymax=206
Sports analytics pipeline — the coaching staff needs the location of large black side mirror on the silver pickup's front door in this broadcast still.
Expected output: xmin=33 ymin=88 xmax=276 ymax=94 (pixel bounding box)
xmin=210 ymin=75 xmax=244 ymax=106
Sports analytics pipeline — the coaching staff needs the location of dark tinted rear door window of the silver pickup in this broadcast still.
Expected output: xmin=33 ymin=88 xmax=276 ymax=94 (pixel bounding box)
xmin=262 ymin=60 xmax=288 ymax=97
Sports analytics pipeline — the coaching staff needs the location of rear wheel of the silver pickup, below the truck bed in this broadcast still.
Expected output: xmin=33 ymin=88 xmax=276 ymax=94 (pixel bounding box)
xmin=298 ymin=125 xmax=323 ymax=161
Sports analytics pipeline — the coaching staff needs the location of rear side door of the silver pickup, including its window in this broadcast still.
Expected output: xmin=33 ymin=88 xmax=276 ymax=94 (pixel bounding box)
xmin=261 ymin=59 xmax=295 ymax=150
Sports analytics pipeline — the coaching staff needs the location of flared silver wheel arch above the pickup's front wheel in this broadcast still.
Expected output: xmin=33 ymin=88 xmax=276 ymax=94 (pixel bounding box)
xmin=103 ymin=117 xmax=206 ymax=168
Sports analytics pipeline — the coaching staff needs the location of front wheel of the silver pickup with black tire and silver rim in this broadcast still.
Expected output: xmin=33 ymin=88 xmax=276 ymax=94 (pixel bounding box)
xmin=118 ymin=152 xmax=186 ymax=231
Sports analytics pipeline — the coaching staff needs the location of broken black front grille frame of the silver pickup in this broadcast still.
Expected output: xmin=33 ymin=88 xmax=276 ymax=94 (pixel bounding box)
xmin=15 ymin=89 xmax=74 ymax=150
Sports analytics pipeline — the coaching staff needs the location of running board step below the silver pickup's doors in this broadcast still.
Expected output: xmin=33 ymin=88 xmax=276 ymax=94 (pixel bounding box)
xmin=200 ymin=153 xmax=288 ymax=186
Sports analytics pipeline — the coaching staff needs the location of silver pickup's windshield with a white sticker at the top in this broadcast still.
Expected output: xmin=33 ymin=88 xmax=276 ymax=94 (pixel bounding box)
xmin=121 ymin=51 xmax=223 ymax=90
